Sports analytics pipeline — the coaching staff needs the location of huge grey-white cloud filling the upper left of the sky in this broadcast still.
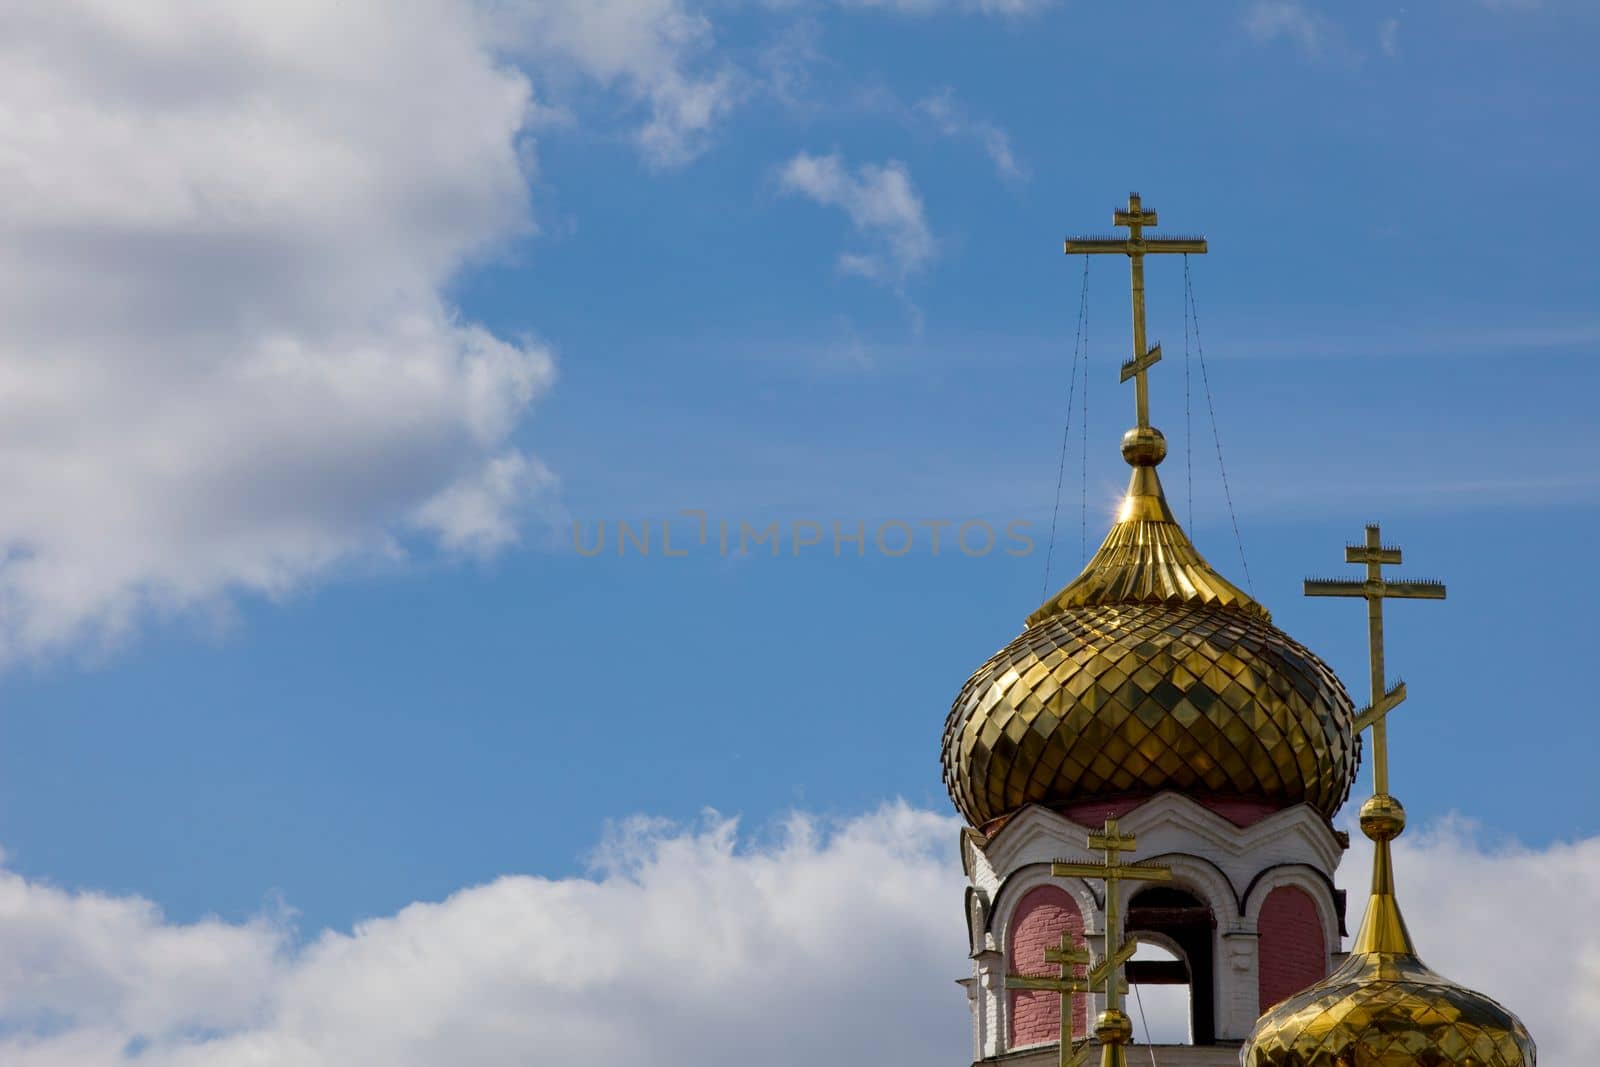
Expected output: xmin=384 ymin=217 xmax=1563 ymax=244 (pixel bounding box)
xmin=0 ymin=0 xmax=728 ymax=661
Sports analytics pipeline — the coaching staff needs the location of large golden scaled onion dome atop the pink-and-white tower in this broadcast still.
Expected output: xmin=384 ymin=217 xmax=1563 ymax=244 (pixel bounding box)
xmin=944 ymin=427 xmax=1360 ymax=827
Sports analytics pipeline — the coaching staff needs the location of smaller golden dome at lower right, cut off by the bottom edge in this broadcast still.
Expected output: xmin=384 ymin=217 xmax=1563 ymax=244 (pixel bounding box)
xmin=1240 ymin=793 xmax=1538 ymax=1067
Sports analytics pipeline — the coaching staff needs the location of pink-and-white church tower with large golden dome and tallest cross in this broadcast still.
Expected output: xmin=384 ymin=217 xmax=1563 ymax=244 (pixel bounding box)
xmin=942 ymin=195 xmax=1360 ymax=1067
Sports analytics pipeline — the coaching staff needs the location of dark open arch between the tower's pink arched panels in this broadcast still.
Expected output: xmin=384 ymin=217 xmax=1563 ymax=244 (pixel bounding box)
xmin=1126 ymin=886 xmax=1216 ymax=1045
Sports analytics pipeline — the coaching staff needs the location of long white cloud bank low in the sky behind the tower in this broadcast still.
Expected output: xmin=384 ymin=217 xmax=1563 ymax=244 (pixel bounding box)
xmin=0 ymin=805 xmax=1600 ymax=1067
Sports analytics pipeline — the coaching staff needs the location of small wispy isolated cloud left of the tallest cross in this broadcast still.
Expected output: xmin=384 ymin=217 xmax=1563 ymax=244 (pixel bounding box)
xmin=779 ymin=152 xmax=938 ymax=286
